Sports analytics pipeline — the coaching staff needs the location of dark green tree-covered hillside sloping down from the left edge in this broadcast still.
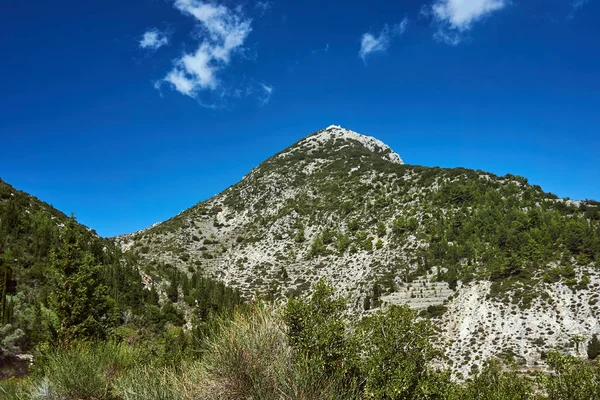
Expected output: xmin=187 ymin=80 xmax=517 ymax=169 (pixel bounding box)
xmin=0 ymin=181 xmax=243 ymax=379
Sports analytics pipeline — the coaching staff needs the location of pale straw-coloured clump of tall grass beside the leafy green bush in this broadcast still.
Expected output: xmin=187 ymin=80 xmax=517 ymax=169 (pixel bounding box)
xmin=192 ymin=304 xmax=355 ymax=400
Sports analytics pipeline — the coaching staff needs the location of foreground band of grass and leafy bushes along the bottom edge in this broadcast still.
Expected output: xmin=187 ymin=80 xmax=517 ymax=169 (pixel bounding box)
xmin=0 ymin=282 xmax=600 ymax=400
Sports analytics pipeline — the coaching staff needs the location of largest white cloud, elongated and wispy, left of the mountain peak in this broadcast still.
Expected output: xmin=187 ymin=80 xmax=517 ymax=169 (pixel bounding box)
xmin=163 ymin=0 xmax=252 ymax=97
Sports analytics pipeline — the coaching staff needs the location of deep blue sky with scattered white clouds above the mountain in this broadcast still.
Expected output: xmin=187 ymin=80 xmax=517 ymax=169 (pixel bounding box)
xmin=0 ymin=0 xmax=600 ymax=236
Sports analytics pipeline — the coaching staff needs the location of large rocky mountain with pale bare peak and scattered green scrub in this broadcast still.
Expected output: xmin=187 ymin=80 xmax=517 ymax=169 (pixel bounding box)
xmin=116 ymin=126 xmax=600 ymax=374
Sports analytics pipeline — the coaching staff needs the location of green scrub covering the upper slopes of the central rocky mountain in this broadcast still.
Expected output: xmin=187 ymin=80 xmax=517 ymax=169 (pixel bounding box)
xmin=143 ymin=128 xmax=600 ymax=307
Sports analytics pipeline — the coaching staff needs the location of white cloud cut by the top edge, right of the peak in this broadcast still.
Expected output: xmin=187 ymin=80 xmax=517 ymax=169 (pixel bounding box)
xmin=422 ymin=0 xmax=509 ymax=46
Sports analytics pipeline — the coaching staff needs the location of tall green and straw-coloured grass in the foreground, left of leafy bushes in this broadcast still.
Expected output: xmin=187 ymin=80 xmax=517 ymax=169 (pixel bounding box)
xmin=0 ymin=304 xmax=348 ymax=400
